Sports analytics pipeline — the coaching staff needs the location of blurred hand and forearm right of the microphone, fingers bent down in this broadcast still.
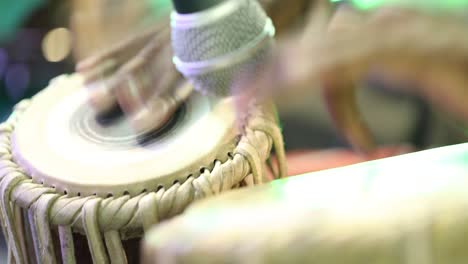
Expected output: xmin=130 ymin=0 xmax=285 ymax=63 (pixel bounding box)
xmin=236 ymin=5 xmax=468 ymax=153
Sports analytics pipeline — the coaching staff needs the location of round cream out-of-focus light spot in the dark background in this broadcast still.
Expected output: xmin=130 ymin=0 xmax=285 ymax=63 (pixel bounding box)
xmin=42 ymin=28 xmax=72 ymax=62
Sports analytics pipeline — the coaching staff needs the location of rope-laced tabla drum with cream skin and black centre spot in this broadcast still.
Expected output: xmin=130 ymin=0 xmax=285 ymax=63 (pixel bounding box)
xmin=0 ymin=74 xmax=285 ymax=263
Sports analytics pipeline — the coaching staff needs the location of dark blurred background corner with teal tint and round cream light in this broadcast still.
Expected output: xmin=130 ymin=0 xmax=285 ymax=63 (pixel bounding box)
xmin=0 ymin=0 xmax=74 ymax=120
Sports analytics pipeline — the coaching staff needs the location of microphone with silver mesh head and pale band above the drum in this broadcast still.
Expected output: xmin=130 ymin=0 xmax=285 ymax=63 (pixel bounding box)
xmin=171 ymin=0 xmax=275 ymax=96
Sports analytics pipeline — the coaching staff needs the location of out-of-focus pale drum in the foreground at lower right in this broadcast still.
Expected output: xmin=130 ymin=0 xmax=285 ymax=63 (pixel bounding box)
xmin=144 ymin=144 xmax=468 ymax=264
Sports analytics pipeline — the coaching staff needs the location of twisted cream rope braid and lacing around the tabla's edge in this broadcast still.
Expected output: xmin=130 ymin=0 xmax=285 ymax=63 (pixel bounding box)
xmin=0 ymin=81 xmax=286 ymax=263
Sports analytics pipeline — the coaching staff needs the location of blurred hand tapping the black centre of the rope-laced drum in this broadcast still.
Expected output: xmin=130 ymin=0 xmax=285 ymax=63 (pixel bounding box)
xmin=77 ymin=20 xmax=191 ymax=132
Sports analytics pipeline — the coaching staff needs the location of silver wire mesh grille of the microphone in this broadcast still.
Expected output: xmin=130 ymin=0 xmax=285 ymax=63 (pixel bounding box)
xmin=172 ymin=0 xmax=273 ymax=95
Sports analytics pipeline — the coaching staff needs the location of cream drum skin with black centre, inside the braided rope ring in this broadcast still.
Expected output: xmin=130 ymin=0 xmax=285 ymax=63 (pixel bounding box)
xmin=12 ymin=75 xmax=236 ymax=197
